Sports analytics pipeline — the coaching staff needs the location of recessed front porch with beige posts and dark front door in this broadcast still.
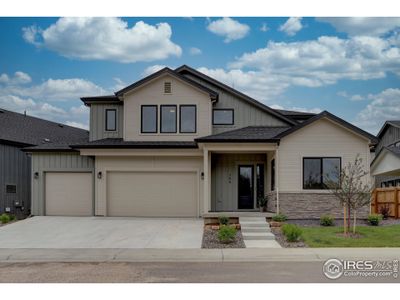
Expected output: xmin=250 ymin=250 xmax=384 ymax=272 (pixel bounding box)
xmin=202 ymin=143 xmax=279 ymax=219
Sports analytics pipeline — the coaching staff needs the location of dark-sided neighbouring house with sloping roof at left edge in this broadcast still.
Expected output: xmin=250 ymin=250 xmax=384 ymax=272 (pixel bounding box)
xmin=0 ymin=109 xmax=88 ymax=216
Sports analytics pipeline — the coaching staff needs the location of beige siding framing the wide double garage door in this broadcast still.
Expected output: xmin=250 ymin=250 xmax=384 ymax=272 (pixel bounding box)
xmin=95 ymin=156 xmax=203 ymax=216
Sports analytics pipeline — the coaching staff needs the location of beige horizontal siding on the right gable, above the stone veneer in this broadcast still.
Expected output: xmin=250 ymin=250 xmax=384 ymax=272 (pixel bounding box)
xmin=278 ymin=119 xmax=370 ymax=193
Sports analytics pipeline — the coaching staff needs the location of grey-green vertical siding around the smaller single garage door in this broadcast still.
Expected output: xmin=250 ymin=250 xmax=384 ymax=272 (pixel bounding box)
xmin=31 ymin=152 xmax=94 ymax=216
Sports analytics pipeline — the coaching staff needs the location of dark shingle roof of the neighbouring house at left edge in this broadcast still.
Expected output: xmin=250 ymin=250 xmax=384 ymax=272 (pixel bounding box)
xmin=0 ymin=109 xmax=89 ymax=149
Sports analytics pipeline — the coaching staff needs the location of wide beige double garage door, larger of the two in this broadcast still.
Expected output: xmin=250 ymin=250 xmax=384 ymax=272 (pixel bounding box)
xmin=107 ymin=171 xmax=198 ymax=217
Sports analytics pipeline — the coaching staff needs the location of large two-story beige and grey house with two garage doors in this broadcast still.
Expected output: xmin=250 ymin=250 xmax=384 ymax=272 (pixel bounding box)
xmin=27 ymin=66 xmax=376 ymax=218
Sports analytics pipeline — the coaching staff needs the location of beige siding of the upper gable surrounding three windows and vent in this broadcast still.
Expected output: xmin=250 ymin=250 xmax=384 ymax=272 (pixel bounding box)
xmin=124 ymin=75 xmax=211 ymax=141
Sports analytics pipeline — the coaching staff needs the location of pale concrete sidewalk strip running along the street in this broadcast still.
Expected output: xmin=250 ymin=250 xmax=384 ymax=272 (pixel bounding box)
xmin=0 ymin=248 xmax=400 ymax=263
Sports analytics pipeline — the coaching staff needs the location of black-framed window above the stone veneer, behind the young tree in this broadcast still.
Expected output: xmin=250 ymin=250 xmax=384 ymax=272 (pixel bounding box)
xmin=303 ymin=157 xmax=342 ymax=190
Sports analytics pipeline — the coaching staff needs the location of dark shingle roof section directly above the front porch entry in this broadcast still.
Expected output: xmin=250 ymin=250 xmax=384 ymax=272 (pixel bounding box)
xmin=196 ymin=126 xmax=290 ymax=143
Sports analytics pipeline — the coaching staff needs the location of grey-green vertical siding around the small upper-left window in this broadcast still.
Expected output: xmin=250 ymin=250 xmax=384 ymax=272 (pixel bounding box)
xmin=89 ymin=104 xmax=124 ymax=141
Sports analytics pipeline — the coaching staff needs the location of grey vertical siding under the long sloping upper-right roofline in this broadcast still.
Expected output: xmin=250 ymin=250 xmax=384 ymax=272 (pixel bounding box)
xmin=185 ymin=75 xmax=288 ymax=134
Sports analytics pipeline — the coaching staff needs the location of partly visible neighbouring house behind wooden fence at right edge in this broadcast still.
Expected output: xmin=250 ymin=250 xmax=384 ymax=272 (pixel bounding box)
xmin=371 ymin=120 xmax=400 ymax=187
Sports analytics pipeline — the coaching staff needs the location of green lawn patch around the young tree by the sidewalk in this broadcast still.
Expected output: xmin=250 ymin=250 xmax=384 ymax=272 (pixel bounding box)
xmin=302 ymin=225 xmax=400 ymax=247
